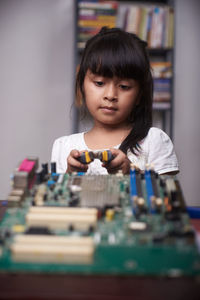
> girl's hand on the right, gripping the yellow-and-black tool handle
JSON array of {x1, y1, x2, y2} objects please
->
[{"x1": 102, "y1": 149, "x2": 131, "y2": 174}]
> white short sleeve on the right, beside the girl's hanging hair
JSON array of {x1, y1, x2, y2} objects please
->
[{"x1": 147, "y1": 128, "x2": 179, "y2": 174}]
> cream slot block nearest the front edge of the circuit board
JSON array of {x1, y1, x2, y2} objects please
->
[{"x1": 10, "y1": 235, "x2": 94, "y2": 264}]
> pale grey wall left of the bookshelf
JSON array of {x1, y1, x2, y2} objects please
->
[{"x1": 0, "y1": 0, "x2": 74, "y2": 199}]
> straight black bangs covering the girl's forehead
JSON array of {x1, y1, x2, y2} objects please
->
[{"x1": 85, "y1": 36, "x2": 146, "y2": 84}]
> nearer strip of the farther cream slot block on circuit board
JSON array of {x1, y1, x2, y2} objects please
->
[{"x1": 26, "y1": 213, "x2": 97, "y2": 231}]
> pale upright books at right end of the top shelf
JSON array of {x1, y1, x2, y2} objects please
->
[{"x1": 117, "y1": 2, "x2": 174, "y2": 48}]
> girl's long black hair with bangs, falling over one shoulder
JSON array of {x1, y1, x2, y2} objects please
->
[{"x1": 76, "y1": 27, "x2": 153, "y2": 154}]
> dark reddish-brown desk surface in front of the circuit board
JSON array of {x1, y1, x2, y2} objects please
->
[{"x1": 0, "y1": 274, "x2": 200, "y2": 300}]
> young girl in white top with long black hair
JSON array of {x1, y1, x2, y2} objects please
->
[{"x1": 51, "y1": 27, "x2": 178, "y2": 174}]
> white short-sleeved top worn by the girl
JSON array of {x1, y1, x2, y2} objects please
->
[{"x1": 51, "y1": 127, "x2": 179, "y2": 174}]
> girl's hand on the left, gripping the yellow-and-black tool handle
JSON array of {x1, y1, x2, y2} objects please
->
[{"x1": 66, "y1": 149, "x2": 88, "y2": 173}]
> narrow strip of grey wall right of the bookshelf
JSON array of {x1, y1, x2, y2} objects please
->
[{"x1": 174, "y1": 0, "x2": 200, "y2": 205}]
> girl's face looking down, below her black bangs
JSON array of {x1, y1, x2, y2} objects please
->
[{"x1": 84, "y1": 70, "x2": 139, "y2": 126}]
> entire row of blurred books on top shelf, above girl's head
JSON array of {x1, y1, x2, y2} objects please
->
[{"x1": 78, "y1": 0, "x2": 174, "y2": 49}]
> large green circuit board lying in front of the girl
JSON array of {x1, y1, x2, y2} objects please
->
[{"x1": 0, "y1": 159, "x2": 200, "y2": 277}]
